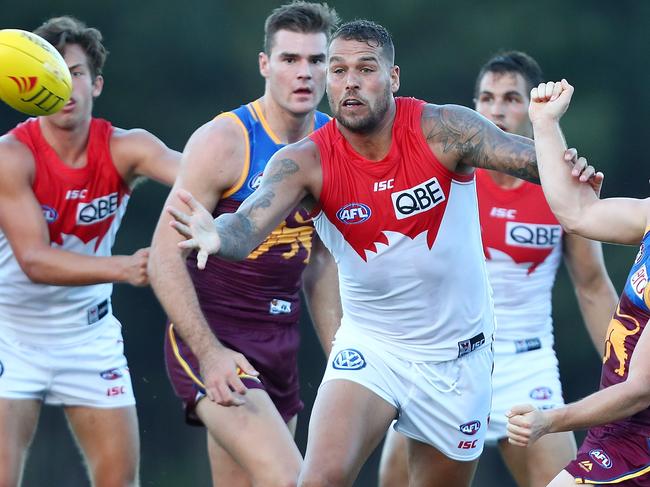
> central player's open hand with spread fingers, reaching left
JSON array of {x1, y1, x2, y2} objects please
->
[{"x1": 166, "y1": 189, "x2": 221, "y2": 269}]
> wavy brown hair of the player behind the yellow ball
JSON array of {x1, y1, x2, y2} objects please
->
[{"x1": 34, "y1": 15, "x2": 108, "y2": 80}]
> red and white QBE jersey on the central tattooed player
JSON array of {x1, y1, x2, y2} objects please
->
[{"x1": 310, "y1": 98, "x2": 494, "y2": 361}]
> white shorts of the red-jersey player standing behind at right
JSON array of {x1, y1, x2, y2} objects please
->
[{"x1": 486, "y1": 347, "x2": 564, "y2": 444}]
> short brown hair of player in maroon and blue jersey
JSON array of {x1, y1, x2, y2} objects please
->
[{"x1": 264, "y1": 1, "x2": 339, "y2": 54}]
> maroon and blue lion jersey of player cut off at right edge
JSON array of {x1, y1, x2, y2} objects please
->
[{"x1": 600, "y1": 227, "x2": 650, "y2": 436}]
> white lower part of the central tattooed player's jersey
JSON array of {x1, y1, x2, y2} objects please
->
[{"x1": 314, "y1": 181, "x2": 494, "y2": 361}]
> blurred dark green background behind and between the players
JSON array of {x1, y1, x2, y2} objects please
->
[{"x1": 0, "y1": 0, "x2": 650, "y2": 487}]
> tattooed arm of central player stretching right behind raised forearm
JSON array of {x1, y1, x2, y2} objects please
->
[{"x1": 422, "y1": 105, "x2": 539, "y2": 184}]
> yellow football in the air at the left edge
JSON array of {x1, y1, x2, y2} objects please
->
[{"x1": 0, "y1": 29, "x2": 72, "y2": 115}]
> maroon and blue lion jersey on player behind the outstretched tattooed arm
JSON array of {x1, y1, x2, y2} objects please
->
[{"x1": 187, "y1": 101, "x2": 329, "y2": 333}]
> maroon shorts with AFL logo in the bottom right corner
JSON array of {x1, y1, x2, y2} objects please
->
[{"x1": 565, "y1": 426, "x2": 650, "y2": 487}]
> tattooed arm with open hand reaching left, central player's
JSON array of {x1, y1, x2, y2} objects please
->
[{"x1": 167, "y1": 139, "x2": 322, "y2": 269}]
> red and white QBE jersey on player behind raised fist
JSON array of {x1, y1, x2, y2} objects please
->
[{"x1": 476, "y1": 169, "x2": 563, "y2": 348}]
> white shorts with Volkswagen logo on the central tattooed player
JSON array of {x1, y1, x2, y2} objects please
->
[{"x1": 323, "y1": 330, "x2": 492, "y2": 461}]
